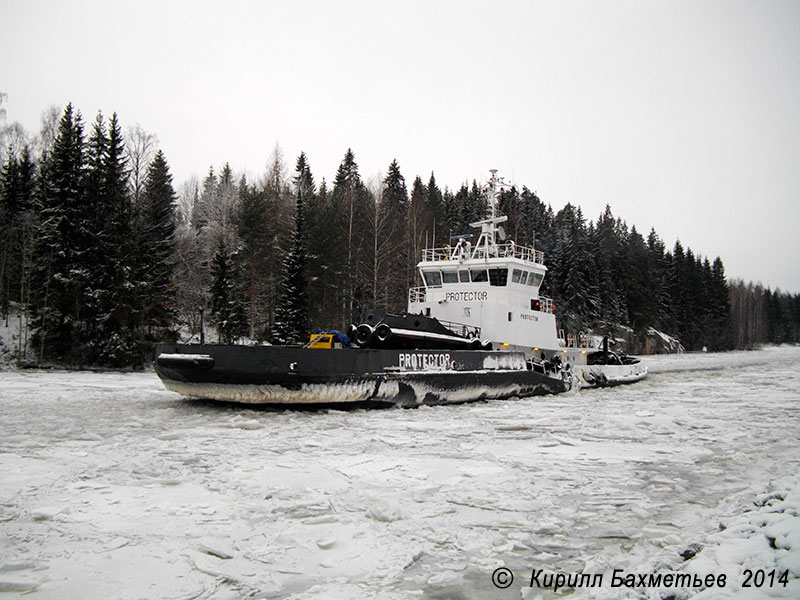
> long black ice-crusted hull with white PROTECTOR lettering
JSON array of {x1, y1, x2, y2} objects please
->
[{"x1": 155, "y1": 344, "x2": 568, "y2": 406}]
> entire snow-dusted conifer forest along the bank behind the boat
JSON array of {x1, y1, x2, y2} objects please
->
[{"x1": 0, "y1": 105, "x2": 800, "y2": 367}]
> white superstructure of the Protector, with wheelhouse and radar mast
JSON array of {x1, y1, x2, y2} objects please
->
[{"x1": 408, "y1": 170, "x2": 563, "y2": 357}]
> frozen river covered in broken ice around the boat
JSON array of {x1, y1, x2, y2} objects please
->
[{"x1": 0, "y1": 348, "x2": 800, "y2": 599}]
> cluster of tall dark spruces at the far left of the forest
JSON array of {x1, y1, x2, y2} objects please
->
[{"x1": 0, "y1": 105, "x2": 176, "y2": 366}]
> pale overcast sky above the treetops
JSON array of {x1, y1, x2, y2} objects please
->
[{"x1": 0, "y1": 0, "x2": 800, "y2": 293}]
